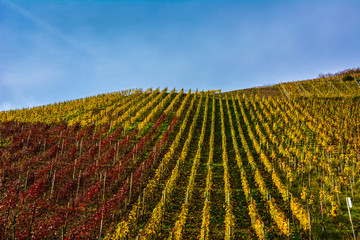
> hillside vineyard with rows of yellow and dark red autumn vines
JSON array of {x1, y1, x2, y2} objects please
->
[{"x1": 0, "y1": 75, "x2": 360, "y2": 240}]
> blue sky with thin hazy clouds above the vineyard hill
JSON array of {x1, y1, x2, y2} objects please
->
[{"x1": 0, "y1": 0, "x2": 360, "y2": 110}]
